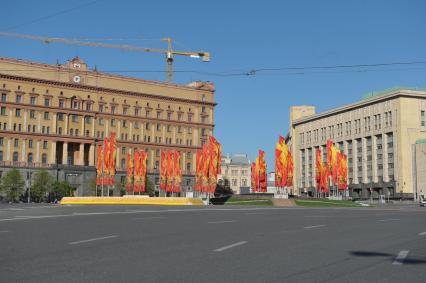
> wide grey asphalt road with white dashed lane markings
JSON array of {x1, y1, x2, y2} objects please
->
[{"x1": 0, "y1": 204, "x2": 426, "y2": 282}]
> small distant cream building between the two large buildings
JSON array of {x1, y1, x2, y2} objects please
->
[{"x1": 218, "y1": 154, "x2": 251, "y2": 194}]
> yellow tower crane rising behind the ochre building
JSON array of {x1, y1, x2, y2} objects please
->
[{"x1": 0, "y1": 32, "x2": 210, "y2": 82}]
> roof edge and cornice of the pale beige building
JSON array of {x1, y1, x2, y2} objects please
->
[{"x1": 292, "y1": 87, "x2": 426, "y2": 125}]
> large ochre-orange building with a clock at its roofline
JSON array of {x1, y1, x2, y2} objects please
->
[{"x1": 0, "y1": 57, "x2": 216, "y2": 195}]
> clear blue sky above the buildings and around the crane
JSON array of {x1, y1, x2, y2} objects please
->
[{"x1": 0, "y1": 0, "x2": 426, "y2": 170}]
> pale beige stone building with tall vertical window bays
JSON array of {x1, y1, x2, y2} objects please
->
[{"x1": 288, "y1": 88, "x2": 426, "y2": 201}]
